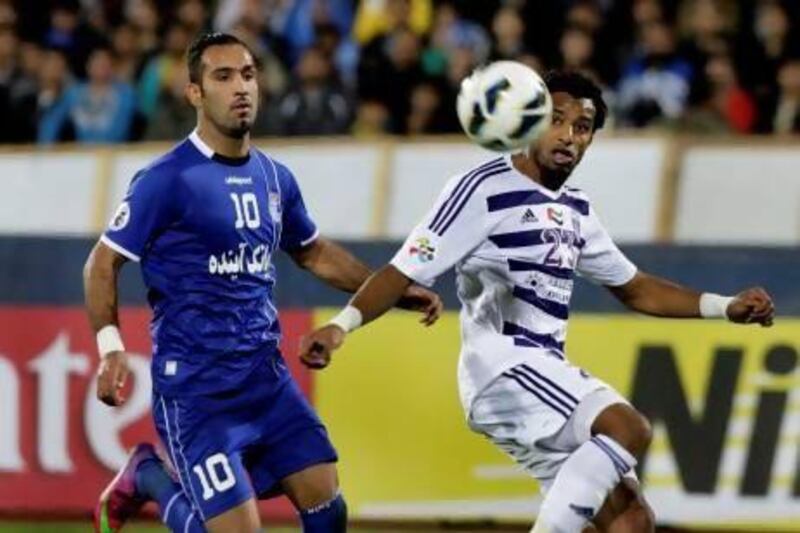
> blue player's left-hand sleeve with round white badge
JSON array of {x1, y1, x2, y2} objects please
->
[{"x1": 100, "y1": 165, "x2": 175, "y2": 262}]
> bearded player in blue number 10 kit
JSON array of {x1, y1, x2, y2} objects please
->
[{"x1": 84, "y1": 33, "x2": 441, "y2": 533}]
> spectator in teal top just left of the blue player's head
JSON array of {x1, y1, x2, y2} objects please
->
[{"x1": 138, "y1": 24, "x2": 191, "y2": 119}]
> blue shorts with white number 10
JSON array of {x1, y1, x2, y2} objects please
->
[{"x1": 153, "y1": 354, "x2": 337, "y2": 521}]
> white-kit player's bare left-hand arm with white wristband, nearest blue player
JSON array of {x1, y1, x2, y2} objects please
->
[{"x1": 300, "y1": 265, "x2": 416, "y2": 369}]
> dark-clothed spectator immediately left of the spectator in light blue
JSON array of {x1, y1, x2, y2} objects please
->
[{"x1": 9, "y1": 49, "x2": 70, "y2": 143}]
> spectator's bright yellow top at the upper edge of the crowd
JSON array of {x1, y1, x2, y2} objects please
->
[{"x1": 353, "y1": 0, "x2": 433, "y2": 45}]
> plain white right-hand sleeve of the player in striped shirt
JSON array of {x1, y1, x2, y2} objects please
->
[{"x1": 576, "y1": 208, "x2": 637, "y2": 287}]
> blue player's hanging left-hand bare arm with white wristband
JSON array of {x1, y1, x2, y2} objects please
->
[{"x1": 83, "y1": 242, "x2": 128, "y2": 405}]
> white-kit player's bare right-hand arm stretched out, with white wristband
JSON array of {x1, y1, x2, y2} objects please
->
[{"x1": 609, "y1": 272, "x2": 775, "y2": 327}]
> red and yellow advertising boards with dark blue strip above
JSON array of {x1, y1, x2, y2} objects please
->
[{"x1": 0, "y1": 237, "x2": 800, "y2": 530}]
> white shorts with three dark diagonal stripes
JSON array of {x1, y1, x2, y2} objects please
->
[{"x1": 468, "y1": 354, "x2": 628, "y2": 491}]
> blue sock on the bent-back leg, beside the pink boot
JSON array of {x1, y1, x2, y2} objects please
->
[{"x1": 136, "y1": 461, "x2": 206, "y2": 533}]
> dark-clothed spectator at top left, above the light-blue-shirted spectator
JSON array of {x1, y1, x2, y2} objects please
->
[{"x1": 44, "y1": 0, "x2": 105, "y2": 77}]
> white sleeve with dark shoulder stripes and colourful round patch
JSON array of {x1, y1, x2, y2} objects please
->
[{"x1": 391, "y1": 171, "x2": 489, "y2": 287}]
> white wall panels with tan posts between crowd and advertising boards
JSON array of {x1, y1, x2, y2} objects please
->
[{"x1": 0, "y1": 135, "x2": 800, "y2": 245}]
